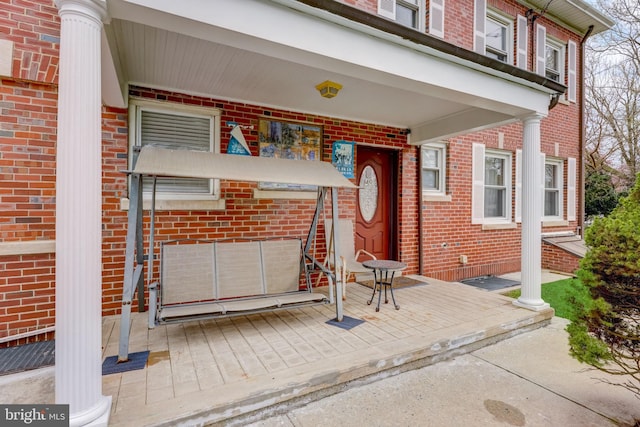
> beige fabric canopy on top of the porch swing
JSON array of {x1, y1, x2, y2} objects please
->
[{"x1": 133, "y1": 147, "x2": 356, "y2": 188}]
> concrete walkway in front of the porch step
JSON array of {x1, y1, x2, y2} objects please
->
[{"x1": 242, "y1": 317, "x2": 640, "y2": 427}]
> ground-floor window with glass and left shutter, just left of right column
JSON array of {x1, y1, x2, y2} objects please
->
[{"x1": 471, "y1": 144, "x2": 512, "y2": 225}]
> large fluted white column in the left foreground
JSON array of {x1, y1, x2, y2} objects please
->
[{"x1": 55, "y1": 0, "x2": 111, "y2": 426}]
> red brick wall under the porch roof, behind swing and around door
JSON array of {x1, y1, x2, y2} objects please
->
[{"x1": 102, "y1": 87, "x2": 410, "y2": 315}]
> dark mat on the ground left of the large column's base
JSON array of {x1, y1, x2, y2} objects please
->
[{"x1": 0, "y1": 340, "x2": 56, "y2": 375}]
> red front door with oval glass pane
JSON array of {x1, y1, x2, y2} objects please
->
[{"x1": 355, "y1": 146, "x2": 396, "y2": 259}]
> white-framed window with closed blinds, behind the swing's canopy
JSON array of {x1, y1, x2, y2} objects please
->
[{"x1": 129, "y1": 99, "x2": 220, "y2": 200}]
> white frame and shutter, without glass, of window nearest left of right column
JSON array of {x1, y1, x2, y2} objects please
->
[{"x1": 471, "y1": 143, "x2": 513, "y2": 226}]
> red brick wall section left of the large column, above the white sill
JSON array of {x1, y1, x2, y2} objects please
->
[{"x1": 0, "y1": 79, "x2": 58, "y2": 242}]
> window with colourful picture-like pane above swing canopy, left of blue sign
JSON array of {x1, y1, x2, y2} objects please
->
[{"x1": 258, "y1": 119, "x2": 322, "y2": 190}]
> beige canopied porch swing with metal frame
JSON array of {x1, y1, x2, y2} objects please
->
[{"x1": 118, "y1": 146, "x2": 356, "y2": 362}]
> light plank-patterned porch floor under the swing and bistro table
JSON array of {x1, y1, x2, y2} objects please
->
[{"x1": 102, "y1": 276, "x2": 553, "y2": 426}]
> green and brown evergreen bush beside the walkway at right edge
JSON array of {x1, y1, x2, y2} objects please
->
[{"x1": 567, "y1": 173, "x2": 640, "y2": 396}]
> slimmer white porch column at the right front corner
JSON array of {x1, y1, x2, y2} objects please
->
[{"x1": 514, "y1": 114, "x2": 549, "y2": 311}]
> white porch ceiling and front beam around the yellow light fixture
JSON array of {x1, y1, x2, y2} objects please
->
[{"x1": 103, "y1": 0, "x2": 554, "y2": 143}]
